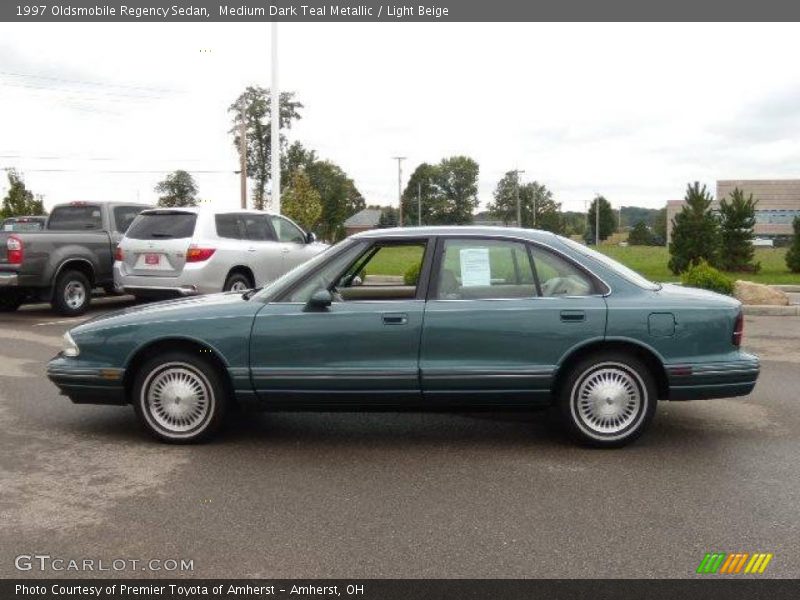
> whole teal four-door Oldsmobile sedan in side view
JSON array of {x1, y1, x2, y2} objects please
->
[{"x1": 48, "y1": 227, "x2": 759, "y2": 447}]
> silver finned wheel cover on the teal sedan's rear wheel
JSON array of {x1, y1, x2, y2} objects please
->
[{"x1": 570, "y1": 363, "x2": 649, "y2": 439}]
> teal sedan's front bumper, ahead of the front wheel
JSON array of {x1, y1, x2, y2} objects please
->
[{"x1": 47, "y1": 355, "x2": 127, "y2": 405}]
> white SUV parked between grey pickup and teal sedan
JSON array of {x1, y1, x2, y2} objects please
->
[{"x1": 114, "y1": 208, "x2": 327, "y2": 298}]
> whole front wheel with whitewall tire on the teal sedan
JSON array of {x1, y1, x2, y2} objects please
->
[{"x1": 131, "y1": 351, "x2": 229, "y2": 444}]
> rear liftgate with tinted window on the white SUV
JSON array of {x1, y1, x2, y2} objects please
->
[{"x1": 121, "y1": 209, "x2": 197, "y2": 277}]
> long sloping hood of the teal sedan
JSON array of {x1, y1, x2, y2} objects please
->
[{"x1": 71, "y1": 292, "x2": 264, "y2": 334}]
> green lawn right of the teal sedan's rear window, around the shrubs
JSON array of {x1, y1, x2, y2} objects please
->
[{"x1": 600, "y1": 244, "x2": 800, "y2": 284}]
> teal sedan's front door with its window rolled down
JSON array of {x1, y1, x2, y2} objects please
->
[{"x1": 250, "y1": 240, "x2": 428, "y2": 407}]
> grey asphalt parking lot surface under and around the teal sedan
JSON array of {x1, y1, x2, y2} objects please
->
[{"x1": 0, "y1": 298, "x2": 800, "y2": 578}]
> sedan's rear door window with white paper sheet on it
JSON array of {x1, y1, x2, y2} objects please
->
[{"x1": 434, "y1": 239, "x2": 536, "y2": 300}]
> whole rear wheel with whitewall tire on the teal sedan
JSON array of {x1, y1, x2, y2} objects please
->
[{"x1": 558, "y1": 352, "x2": 658, "y2": 448}]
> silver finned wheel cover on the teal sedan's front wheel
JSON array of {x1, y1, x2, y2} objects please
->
[{"x1": 142, "y1": 363, "x2": 214, "y2": 436}]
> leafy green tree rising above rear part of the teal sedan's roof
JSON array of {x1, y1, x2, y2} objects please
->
[{"x1": 488, "y1": 171, "x2": 566, "y2": 233}]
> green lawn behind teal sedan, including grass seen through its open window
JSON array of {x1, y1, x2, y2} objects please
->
[{"x1": 367, "y1": 239, "x2": 800, "y2": 285}]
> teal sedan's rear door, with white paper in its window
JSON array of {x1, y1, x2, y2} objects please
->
[{"x1": 420, "y1": 237, "x2": 606, "y2": 406}]
